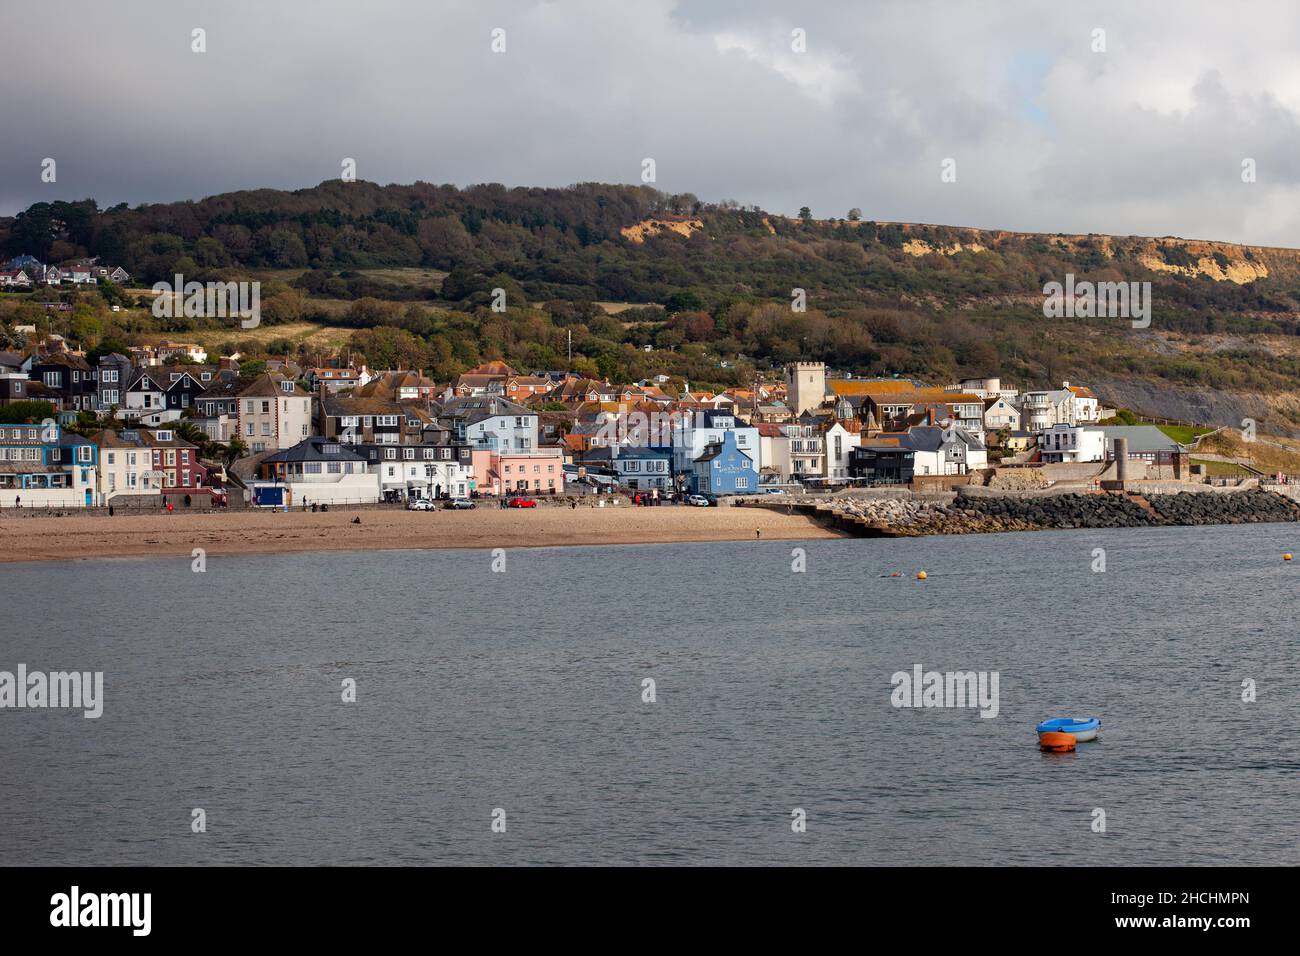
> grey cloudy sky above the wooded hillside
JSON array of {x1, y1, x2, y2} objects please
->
[{"x1": 0, "y1": 0, "x2": 1300, "y2": 246}]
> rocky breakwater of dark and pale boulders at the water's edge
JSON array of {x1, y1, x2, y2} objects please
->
[{"x1": 835, "y1": 492, "x2": 1300, "y2": 537}]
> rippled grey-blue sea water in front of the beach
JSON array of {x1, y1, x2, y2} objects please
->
[{"x1": 0, "y1": 525, "x2": 1300, "y2": 865}]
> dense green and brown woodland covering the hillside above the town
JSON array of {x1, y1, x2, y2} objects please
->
[{"x1": 0, "y1": 181, "x2": 1300, "y2": 390}]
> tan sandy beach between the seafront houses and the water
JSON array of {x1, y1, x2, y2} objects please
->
[{"x1": 0, "y1": 505, "x2": 837, "y2": 563}]
